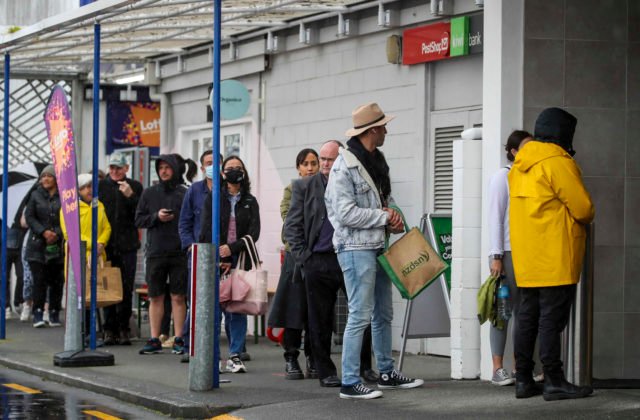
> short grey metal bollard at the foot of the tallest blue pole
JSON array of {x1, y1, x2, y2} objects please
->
[{"x1": 189, "y1": 244, "x2": 218, "y2": 391}]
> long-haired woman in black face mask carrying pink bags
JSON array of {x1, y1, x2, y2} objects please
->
[{"x1": 199, "y1": 156, "x2": 260, "y2": 373}]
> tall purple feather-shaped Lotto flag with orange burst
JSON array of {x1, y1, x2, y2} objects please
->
[{"x1": 44, "y1": 85, "x2": 82, "y2": 305}]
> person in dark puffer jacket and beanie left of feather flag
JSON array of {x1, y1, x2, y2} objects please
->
[{"x1": 25, "y1": 165, "x2": 64, "y2": 328}]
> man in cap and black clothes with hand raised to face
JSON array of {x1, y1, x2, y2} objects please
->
[{"x1": 98, "y1": 153, "x2": 142, "y2": 346}]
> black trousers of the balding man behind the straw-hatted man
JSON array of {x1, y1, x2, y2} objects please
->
[{"x1": 302, "y1": 252, "x2": 371, "y2": 379}]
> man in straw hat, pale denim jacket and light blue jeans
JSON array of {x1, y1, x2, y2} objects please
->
[{"x1": 325, "y1": 103, "x2": 423, "y2": 399}]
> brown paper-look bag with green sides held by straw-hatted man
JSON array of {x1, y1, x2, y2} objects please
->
[{"x1": 378, "y1": 209, "x2": 448, "y2": 300}]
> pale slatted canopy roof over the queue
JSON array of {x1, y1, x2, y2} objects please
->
[{"x1": 0, "y1": 0, "x2": 363, "y2": 75}]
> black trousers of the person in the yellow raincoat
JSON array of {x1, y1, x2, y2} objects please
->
[{"x1": 514, "y1": 284, "x2": 576, "y2": 382}]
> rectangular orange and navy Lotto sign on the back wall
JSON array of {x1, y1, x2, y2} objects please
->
[{"x1": 107, "y1": 101, "x2": 160, "y2": 154}]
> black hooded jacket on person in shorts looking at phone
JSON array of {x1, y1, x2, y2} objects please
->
[{"x1": 135, "y1": 155, "x2": 187, "y2": 257}]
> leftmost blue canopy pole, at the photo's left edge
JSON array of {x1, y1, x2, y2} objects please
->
[{"x1": 0, "y1": 54, "x2": 10, "y2": 340}]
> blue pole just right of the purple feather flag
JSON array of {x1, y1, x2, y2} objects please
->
[{"x1": 89, "y1": 23, "x2": 100, "y2": 350}]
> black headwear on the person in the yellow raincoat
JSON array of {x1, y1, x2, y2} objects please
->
[{"x1": 533, "y1": 108, "x2": 578, "y2": 156}]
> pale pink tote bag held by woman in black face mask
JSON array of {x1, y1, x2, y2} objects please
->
[{"x1": 223, "y1": 235, "x2": 269, "y2": 315}]
